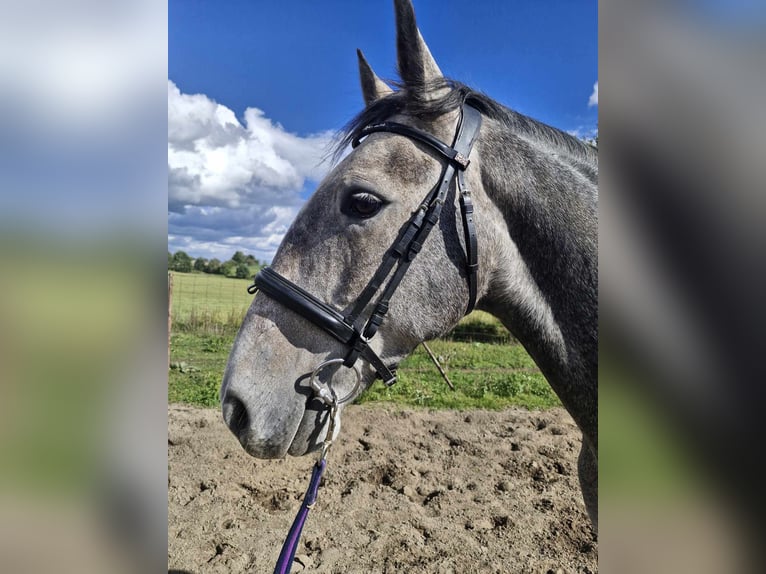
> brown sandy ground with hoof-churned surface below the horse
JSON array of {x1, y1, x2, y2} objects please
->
[{"x1": 168, "y1": 405, "x2": 598, "y2": 574}]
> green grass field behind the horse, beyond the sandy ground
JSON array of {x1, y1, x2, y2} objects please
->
[{"x1": 168, "y1": 273, "x2": 560, "y2": 409}]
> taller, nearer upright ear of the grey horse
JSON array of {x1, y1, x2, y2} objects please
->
[{"x1": 394, "y1": 0, "x2": 444, "y2": 96}]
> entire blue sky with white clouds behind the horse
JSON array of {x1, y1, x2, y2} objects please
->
[{"x1": 168, "y1": 0, "x2": 598, "y2": 260}]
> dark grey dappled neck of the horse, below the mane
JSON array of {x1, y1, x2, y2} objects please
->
[{"x1": 481, "y1": 122, "x2": 598, "y2": 431}]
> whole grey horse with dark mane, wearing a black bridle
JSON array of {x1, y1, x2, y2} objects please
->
[{"x1": 221, "y1": 0, "x2": 598, "y2": 526}]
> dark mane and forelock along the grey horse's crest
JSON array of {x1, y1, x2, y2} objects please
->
[{"x1": 334, "y1": 79, "x2": 598, "y2": 164}]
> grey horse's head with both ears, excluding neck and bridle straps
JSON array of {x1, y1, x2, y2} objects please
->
[{"x1": 221, "y1": 0, "x2": 492, "y2": 458}]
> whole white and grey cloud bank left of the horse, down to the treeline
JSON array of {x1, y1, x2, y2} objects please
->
[{"x1": 168, "y1": 81, "x2": 332, "y2": 259}]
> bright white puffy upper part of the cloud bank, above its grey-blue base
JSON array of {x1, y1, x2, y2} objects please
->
[{"x1": 168, "y1": 81, "x2": 331, "y2": 211}]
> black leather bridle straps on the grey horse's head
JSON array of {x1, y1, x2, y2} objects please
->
[{"x1": 248, "y1": 104, "x2": 481, "y2": 392}]
